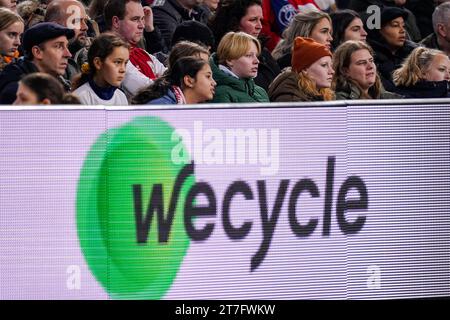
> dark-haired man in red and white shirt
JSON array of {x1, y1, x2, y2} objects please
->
[{"x1": 105, "y1": 0, "x2": 166, "y2": 97}]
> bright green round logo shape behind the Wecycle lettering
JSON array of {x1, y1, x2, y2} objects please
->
[{"x1": 77, "y1": 117, "x2": 194, "y2": 299}]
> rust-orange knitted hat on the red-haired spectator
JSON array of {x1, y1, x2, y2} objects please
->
[{"x1": 291, "y1": 37, "x2": 332, "y2": 72}]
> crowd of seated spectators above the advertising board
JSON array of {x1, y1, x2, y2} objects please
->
[{"x1": 0, "y1": 0, "x2": 450, "y2": 105}]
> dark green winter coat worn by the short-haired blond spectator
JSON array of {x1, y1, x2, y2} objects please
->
[{"x1": 209, "y1": 53, "x2": 269, "y2": 103}]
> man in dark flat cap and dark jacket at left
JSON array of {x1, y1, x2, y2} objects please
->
[{"x1": 0, "y1": 22, "x2": 75, "y2": 104}]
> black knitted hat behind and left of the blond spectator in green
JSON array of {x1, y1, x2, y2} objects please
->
[{"x1": 172, "y1": 20, "x2": 214, "y2": 48}]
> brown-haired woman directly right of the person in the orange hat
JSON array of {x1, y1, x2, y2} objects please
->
[{"x1": 333, "y1": 40, "x2": 400, "y2": 100}]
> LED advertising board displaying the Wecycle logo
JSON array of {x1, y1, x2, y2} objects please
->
[{"x1": 0, "y1": 103, "x2": 450, "y2": 299}]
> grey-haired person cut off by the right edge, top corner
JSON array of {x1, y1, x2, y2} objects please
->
[{"x1": 420, "y1": 2, "x2": 450, "y2": 56}]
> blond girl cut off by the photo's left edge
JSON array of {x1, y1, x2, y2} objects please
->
[{"x1": 0, "y1": 8, "x2": 24, "y2": 72}]
